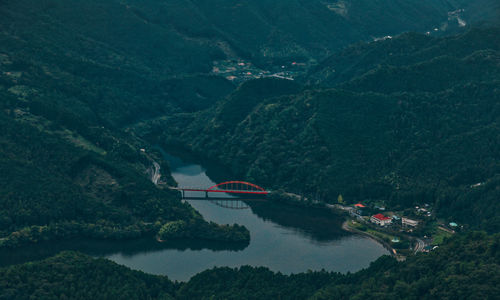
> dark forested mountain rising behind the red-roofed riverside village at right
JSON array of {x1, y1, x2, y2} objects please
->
[{"x1": 137, "y1": 28, "x2": 500, "y2": 231}]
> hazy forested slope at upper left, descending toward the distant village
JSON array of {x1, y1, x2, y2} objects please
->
[{"x1": 0, "y1": 0, "x2": 233, "y2": 126}]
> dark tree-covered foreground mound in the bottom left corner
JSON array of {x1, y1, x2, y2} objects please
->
[{"x1": 0, "y1": 252, "x2": 175, "y2": 299}]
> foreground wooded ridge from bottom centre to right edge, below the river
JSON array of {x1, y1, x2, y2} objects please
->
[{"x1": 178, "y1": 232, "x2": 500, "y2": 299}]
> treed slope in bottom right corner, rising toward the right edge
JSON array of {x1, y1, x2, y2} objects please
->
[{"x1": 312, "y1": 232, "x2": 500, "y2": 299}]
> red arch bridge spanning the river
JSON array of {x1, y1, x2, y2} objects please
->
[{"x1": 172, "y1": 181, "x2": 270, "y2": 198}]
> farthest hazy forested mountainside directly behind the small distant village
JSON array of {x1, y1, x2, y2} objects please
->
[{"x1": 122, "y1": 0, "x2": 495, "y2": 65}]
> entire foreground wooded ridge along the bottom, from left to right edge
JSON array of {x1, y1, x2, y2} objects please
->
[{"x1": 0, "y1": 232, "x2": 500, "y2": 299}]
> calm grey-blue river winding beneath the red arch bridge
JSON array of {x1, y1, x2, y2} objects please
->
[{"x1": 0, "y1": 153, "x2": 389, "y2": 281}]
